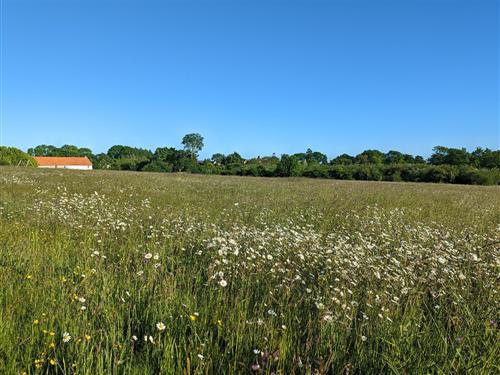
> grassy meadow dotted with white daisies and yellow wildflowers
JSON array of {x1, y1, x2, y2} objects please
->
[{"x1": 0, "y1": 168, "x2": 500, "y2": 374}]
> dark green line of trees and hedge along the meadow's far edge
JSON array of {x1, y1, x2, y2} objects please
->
[{"x1": 0, "y1": 133, "x2": 500, "y2": 185}]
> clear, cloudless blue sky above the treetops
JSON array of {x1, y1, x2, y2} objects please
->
[{"x1": 1, "y1": 0, "x2": 500, "y2": 157}]
